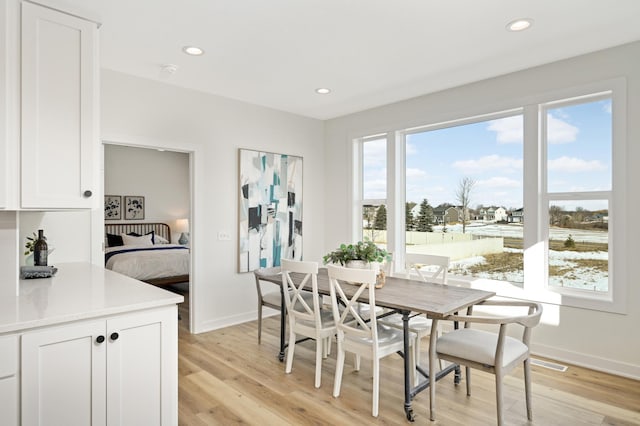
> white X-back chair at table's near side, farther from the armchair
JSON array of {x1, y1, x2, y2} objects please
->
[{"x1": 281, "y1": 259, "x2": 336, "y2": 388}]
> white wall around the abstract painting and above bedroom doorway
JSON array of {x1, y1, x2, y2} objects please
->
[{"x1": 101, "y1": 70, "x2": 325, "y2": 332}]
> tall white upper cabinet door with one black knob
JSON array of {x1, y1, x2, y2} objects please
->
[{"x1": 21, "y1": 2, "x2": 99, "y2": 209}]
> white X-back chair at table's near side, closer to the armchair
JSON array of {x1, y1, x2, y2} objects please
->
[{"x1": 327, "y1": 265, "x2": 415, "y2": 417}]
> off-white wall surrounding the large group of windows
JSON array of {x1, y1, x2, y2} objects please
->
[{"x1": 324, "y1": 42, "x2": 640, "y2": 377}]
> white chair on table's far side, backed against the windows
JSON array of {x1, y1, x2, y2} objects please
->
[{"x1": 380, "y1": 253, "x2": 449, "y2": 383}]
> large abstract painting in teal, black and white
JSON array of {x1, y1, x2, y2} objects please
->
[{"x1": 238, "y1": 149, "x2": 302, "y2": 272}]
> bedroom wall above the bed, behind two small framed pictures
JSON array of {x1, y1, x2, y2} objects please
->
[{"x1": 104, "y1": 144, "x2": 190, "y2": 241}]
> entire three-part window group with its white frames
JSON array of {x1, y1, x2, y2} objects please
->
[{"x1": 354, "y1": 80, "x2": 626, "y2": 312}]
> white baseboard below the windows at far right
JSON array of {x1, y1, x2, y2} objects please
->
[{"x1": 531, "y1": 343, "x2": 640, "y2": 380}]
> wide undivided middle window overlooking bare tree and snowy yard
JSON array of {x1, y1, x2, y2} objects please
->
[{"x1": 405, "y1": 114, "x2": 524, "y2": 284}]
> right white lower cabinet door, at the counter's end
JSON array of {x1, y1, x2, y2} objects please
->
[{"x1": 107, "y1": 306, "x2": 178, "y2": 426}]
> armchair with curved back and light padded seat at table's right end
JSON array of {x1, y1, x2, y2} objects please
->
[{"x1": 429, "y1": 300, "x2": 542, "y2": 426}]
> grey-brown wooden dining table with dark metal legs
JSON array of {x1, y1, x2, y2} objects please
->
[{"x1": 260, "y1": 268, "x2": 495, "y2": 421}]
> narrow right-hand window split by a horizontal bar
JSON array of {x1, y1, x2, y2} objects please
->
[{"x1": 541, "y1": 93, "x2": 613, "y2": 293}]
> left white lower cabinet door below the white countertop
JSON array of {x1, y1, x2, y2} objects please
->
[{"x1": 21, "y1": 320, "x2": 107, "y2": 426}]
